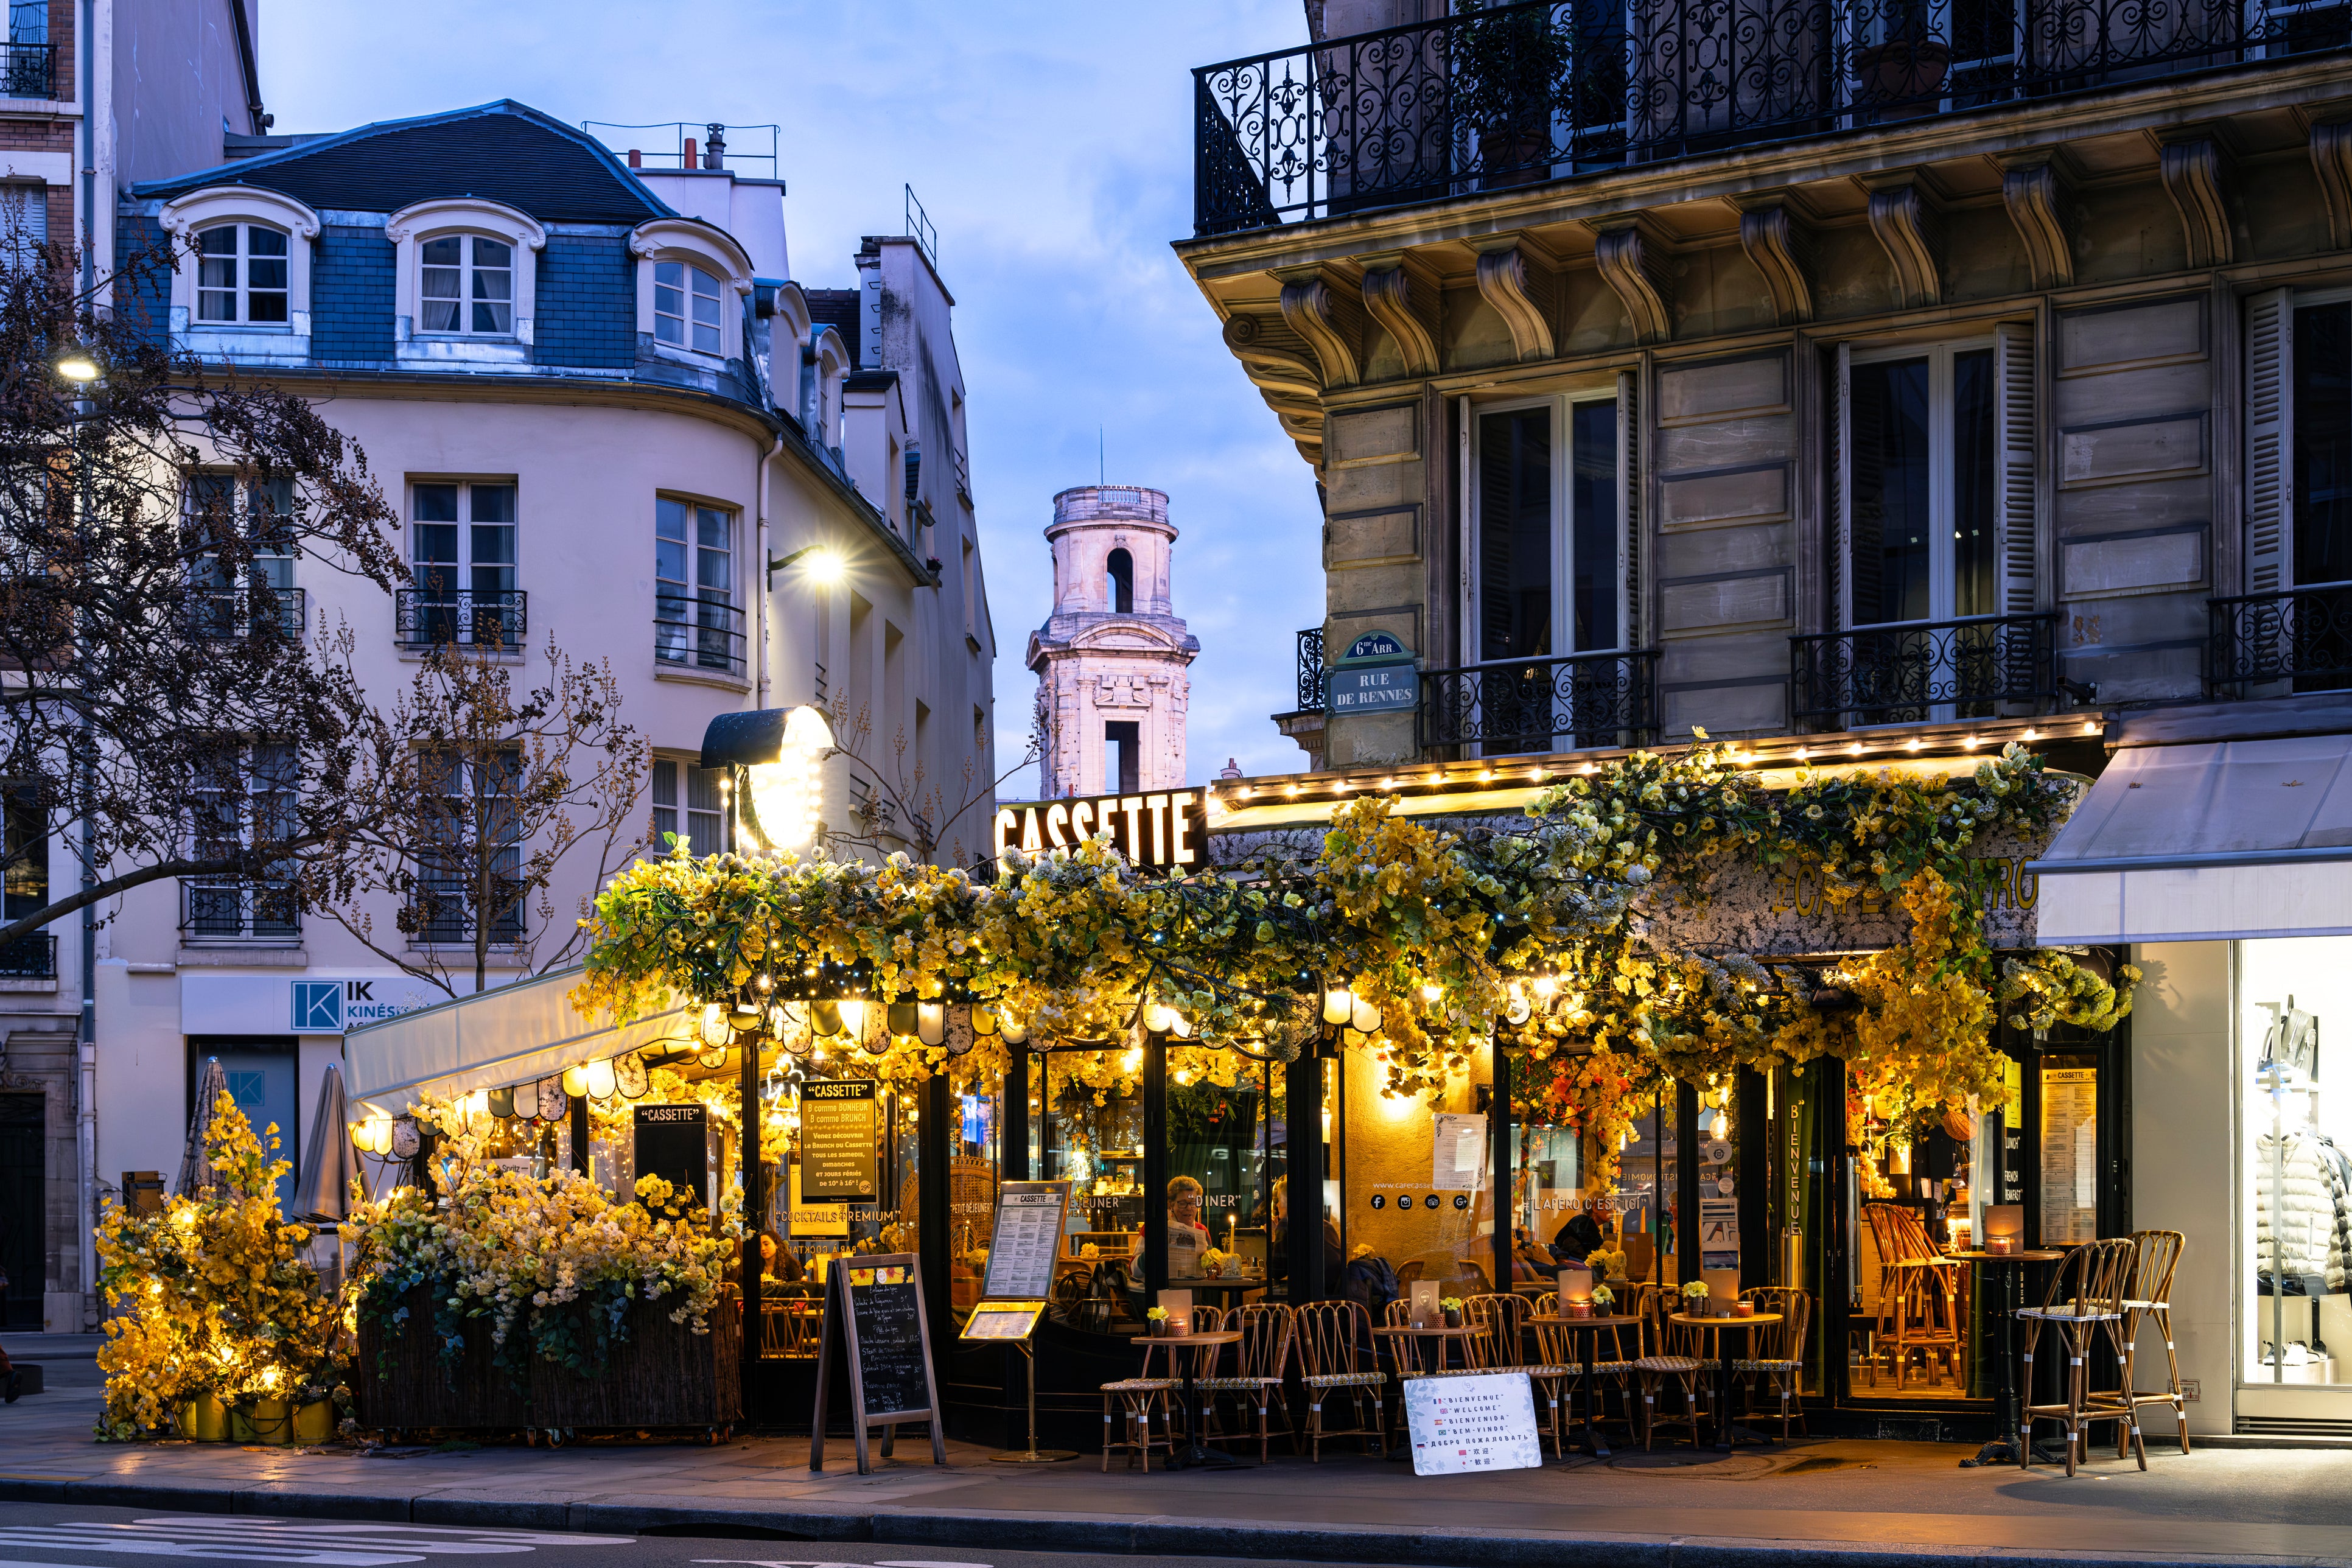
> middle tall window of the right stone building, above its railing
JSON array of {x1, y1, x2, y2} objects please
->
[{"x1": 1846, "y1": 346, "x2": 1999, "y2": 625}]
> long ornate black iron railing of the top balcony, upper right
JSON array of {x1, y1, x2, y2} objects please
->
[{"x1": 1192, "y1": 0, "x2": 2352, "y2": 235}]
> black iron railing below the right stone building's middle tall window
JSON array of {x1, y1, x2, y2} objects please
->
[{"x1": 1788, "y1": 614, "x2": 2058, "y2": 729}]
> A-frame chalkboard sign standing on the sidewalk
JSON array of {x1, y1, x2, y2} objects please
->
[{"x1": 809, "y1": 1253, "x2": 948, "y2": 1476}]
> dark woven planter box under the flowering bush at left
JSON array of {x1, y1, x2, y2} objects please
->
[{"x1": 351, "y1": 1290, "x2": 743, "y2": 1429}]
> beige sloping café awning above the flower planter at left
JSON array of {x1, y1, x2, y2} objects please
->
[{"x1": 343, "y1": 964, "x2": 696, "y2": 1116}]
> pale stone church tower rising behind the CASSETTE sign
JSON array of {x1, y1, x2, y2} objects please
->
[{"x1": 1028, "y1": 485, "x2": 1200, "y2": 799}]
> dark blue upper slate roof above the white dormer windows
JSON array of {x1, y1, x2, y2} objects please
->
[{"x1": 131, "y1": 99, "x2": 677, "y2": 226}]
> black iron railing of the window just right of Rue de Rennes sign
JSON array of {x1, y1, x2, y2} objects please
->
[{"x1": 1418, "y1": 649, "x2": 1658, "y2": 757}]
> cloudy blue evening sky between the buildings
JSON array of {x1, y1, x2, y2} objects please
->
[{"x1": 261, "y1": 0, "x2": 1322, "y2": 794}]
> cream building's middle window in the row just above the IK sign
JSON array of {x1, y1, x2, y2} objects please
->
[{"x1": 414, "y1": 750, "x2": 525, "y2": 943}]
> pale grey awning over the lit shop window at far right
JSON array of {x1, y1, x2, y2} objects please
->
[{"x1": 2032, "y1": 733, "x2": 2352, "y2": 947}]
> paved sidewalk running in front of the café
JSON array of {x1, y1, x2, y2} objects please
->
[{"x1": 0, "y1": 1368, "x2": 2352, "y2": 1568}]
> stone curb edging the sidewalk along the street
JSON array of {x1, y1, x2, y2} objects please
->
[{"x1": 0, "y1": 1476, "x2": 2352, "y2": 1568}]
